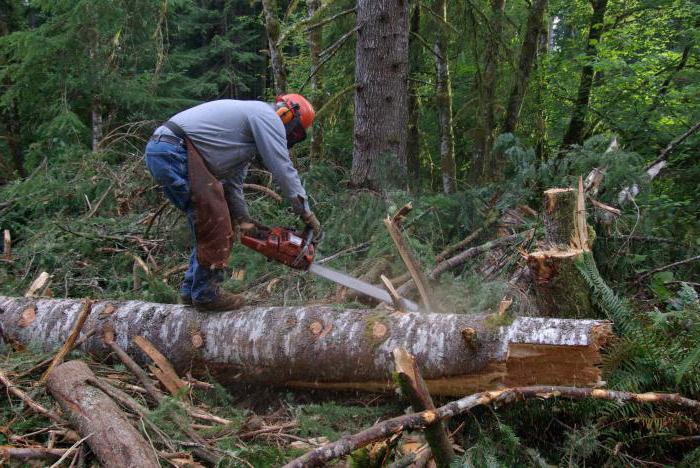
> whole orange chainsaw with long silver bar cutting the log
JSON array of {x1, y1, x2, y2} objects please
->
[{"x1": 241, "y1": 225, "x2": 420, "y2": 312}]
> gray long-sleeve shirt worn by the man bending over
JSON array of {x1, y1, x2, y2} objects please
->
[{"x1": 154, "y1": 99, "x2": 309, "y2": 218}]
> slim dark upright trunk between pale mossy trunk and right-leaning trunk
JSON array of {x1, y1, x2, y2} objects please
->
[{"x1": 475, "y1": 0, "x2": 506, "y2": 180}]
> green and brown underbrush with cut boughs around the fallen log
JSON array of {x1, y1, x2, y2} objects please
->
[{"x1": 0, "y1": 137, "x2": 700, "y2": 466}]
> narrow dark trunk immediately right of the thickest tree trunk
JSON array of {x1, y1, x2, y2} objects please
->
[{"x1": 406, "y1": 2, "x2": 422, "y2": 191}]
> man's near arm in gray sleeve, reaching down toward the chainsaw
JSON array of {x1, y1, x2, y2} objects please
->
[{"x1": 249, "y1": 112, "x2": 311, "y2": 215}]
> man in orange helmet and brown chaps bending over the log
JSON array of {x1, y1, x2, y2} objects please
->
[{"x1": 146, "y1": 94, "x2": 321, "y2": 311}]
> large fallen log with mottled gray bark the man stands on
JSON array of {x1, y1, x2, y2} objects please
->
[{"x1": 0, "y1": 296, "x2": 612, "y2": 395}]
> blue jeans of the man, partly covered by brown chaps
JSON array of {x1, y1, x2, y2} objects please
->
[{"x1": 146, "y1": 140, "x2": 224, "y2": 303}]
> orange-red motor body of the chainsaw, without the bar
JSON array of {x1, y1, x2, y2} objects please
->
[{"x1": 241, "y1": 227, "x2": 315, "y2": 270}]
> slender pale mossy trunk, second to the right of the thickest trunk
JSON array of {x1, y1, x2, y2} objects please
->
[{"x1": 434, "y1": 0, "x2": 457, "y2": 195}]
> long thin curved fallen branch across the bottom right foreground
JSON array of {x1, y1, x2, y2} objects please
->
[{"x1": 284, "y1": 386, "x2": 700, "y2": 468}]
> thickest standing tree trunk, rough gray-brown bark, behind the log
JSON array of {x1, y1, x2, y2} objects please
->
[{"x1": 352, "y1": 0, "x2": 408, "y2": 190}]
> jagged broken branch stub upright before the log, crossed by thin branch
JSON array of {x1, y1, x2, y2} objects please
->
[{"x1": 392, "y1": 348, "x2": 455, "y2": 468}]
